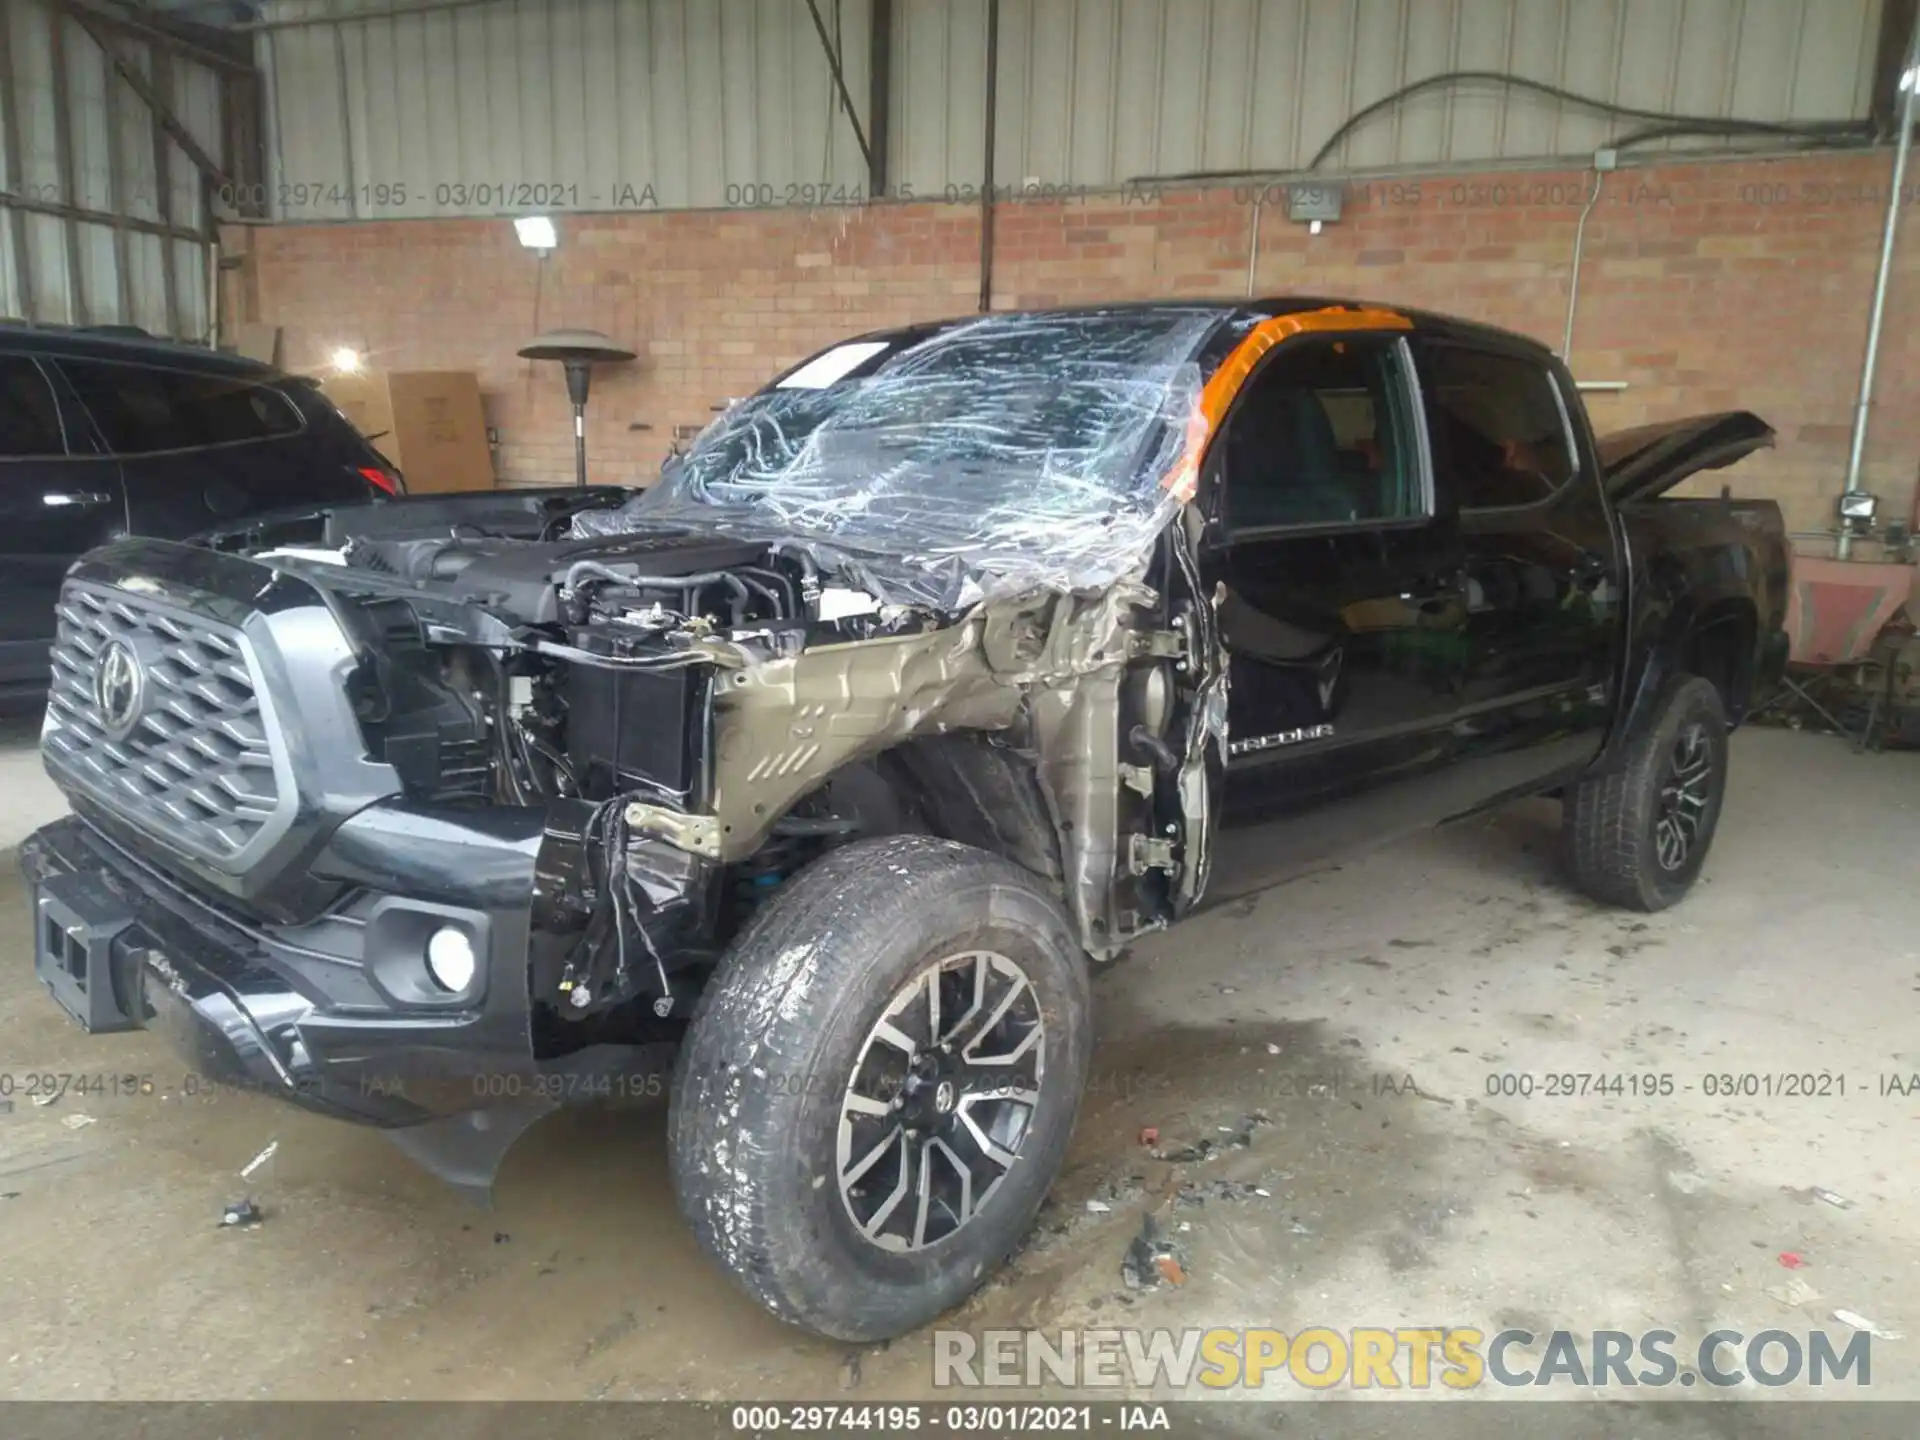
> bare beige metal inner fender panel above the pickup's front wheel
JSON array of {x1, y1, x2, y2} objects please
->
[{"x1": 624, "y1": 556, "x2": 1223, "y2": 960}]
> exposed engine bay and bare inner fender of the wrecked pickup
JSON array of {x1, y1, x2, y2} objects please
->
[{"x1": 213, "y1": 492, "x2": 1225, "y2": 1054}]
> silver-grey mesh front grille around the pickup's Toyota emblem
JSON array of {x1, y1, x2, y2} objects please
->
[{"x1": 40, "y1": 584, "x2": 284, "y2": 864}]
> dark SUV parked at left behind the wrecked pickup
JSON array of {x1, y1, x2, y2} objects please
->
[{"x1": 0, "y1": 326, "x2": 401, "y2": 697}]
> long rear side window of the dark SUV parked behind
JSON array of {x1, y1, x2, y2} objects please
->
[{"x1": 60, "y1": 361, "x2": 300, "y2": 455}]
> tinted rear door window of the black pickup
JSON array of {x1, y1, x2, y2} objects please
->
[{"x1": 1421, "y1": 346, "x2": 1572, "y2": 509}]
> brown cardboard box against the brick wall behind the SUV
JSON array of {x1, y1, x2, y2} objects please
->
[{"x1": 323, "y1": 371, "x2": 493, "y2": 495}]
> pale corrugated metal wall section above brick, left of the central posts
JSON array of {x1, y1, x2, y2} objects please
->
[{"x1": 259, "y1": 0, "x2": 868, "y2": 219}]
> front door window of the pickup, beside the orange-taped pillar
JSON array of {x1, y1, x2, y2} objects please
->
[{"x1": 1221, "y1": 340, "x2": 1425, "y2": 530}]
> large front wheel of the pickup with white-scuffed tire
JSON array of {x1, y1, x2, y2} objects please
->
[{"x1": 668, "y1": 835, "x2": 1092, "y2": 1340}]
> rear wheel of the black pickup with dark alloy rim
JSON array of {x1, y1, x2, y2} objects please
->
[{"x1": 1565, "y1": 676, "x2": 1726, "y2": 910}]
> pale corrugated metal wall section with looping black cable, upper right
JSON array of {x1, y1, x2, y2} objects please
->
[{"x1": 917, "y1": 0, "x2": 1880, "y2": 186}]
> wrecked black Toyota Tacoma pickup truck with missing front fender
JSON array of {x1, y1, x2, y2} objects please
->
[{"x1": 25, "y1": 300, "x2": 1788, "y2": 1338}]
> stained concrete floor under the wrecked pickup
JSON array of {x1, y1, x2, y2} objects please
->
[{"x1": 0, "y1": 732, "x2": 1920, "y2": 1400}]
